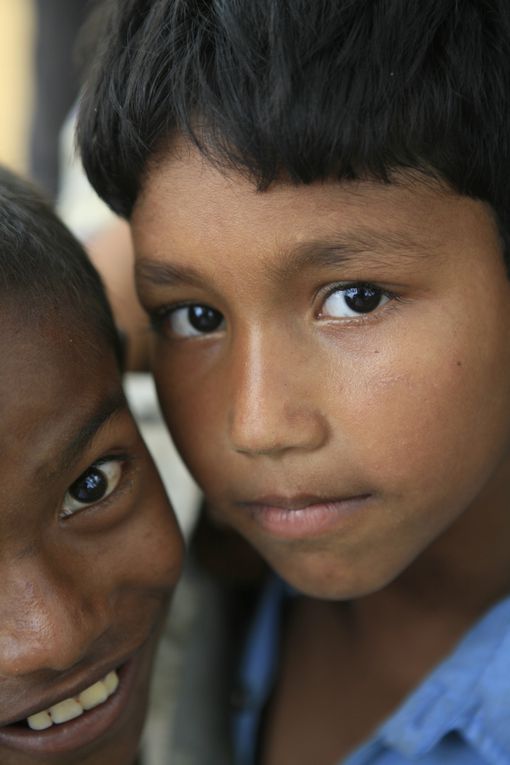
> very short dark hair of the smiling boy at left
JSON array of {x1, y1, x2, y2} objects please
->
[{"x1": 0, "y1": 166, "x2": 123, "y2": 367}]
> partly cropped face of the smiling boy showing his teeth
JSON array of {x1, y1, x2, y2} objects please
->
[{"x1": 0, "y1": 306, "x2": 182, "y2": 765}]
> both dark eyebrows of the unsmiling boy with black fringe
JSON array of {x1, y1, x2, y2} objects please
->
[{"x1": 135, "y1": 228, "x2": 434, "y2": 287}]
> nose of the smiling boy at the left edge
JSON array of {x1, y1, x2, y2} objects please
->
[{"x1": 0, "y1": 561, "x2": 103, "y2": 677}]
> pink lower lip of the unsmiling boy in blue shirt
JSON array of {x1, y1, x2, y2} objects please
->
[{"x1": 245, "y1": 494, "x2": 371, "y2": 539}]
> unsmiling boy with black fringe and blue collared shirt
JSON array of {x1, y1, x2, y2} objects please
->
[{"x1": 79, "y1": 0, "x2": 510, "y2": 765}]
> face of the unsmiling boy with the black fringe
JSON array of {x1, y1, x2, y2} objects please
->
[{"x1": 132, "y1": 146, "x2": 510, "y2": 598}]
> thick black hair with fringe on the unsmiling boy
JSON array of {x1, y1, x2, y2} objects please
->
[{"x1": 78, "y1": 0, "x2": 510, "y2": 254}]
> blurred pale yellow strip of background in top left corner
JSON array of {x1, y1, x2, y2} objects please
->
[{"x1": 0, "y1": 0, "x2": 33, "y2": 172}]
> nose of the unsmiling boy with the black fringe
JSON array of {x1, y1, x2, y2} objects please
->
[{"x1": 227, "y1": 326, "x2": 329, "y2": 456}]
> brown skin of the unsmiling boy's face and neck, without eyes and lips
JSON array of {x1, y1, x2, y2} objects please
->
[{"x1": 132, "y1": 142, "x2": 510, "y2": 764}]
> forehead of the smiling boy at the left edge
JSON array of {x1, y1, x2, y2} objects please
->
[{"x1": 0, "y1": 311, "x2": 127, "y2": 480}]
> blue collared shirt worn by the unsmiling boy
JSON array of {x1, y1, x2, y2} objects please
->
[{"x1": 233, "y1": 579, "x2": 510, "y2": 765}]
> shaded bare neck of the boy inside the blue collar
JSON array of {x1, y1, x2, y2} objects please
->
[{"x1": 262, "y1": 510, "x2": 510, "y2": 765}]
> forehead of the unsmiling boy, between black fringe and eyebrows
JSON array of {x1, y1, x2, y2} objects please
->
[{"x1": 131, "y1": 145, "x2": 495, "y2": 272}]
